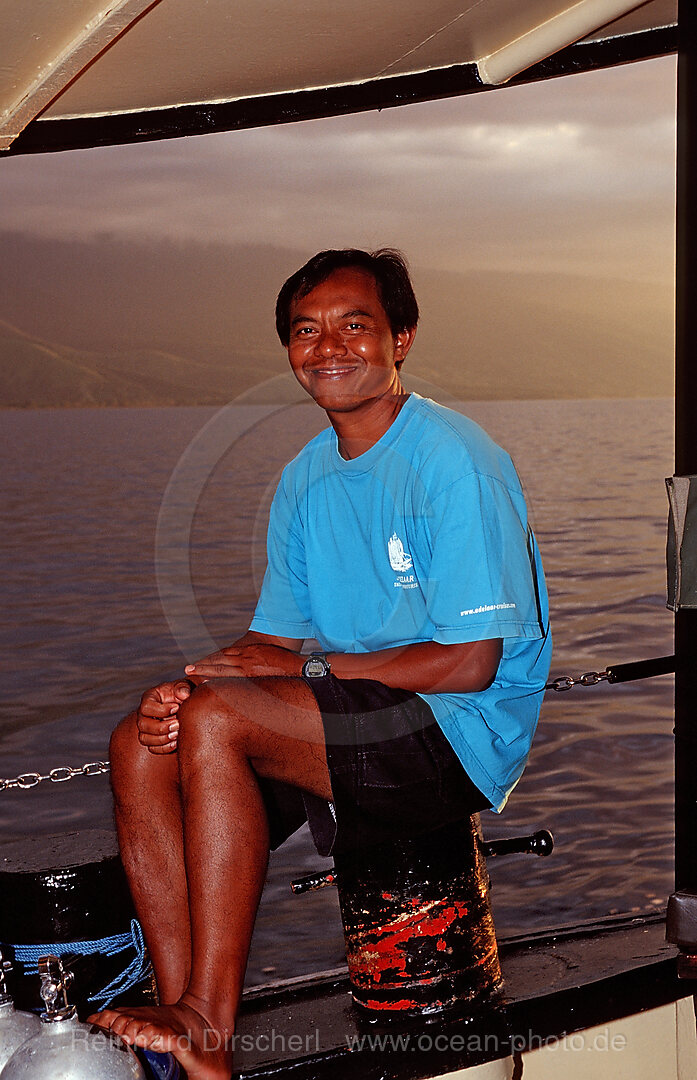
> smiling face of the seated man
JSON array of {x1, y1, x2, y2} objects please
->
[{"x1": 289, "y1": 267, "x2": 415, "y2": 413}]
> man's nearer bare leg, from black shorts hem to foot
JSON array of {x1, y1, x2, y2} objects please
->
[{"x1": 89, "y1": 678, "x2": 331, "y2": 1080}]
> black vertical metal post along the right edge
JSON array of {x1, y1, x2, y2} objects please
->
[{"x1": 675, "y1": 0, "x2": 697, "y2": 894}]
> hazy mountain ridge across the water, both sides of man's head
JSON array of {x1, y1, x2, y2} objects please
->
[{"x1": 0, "y1": 233, "x2": 672, "y2": 407}]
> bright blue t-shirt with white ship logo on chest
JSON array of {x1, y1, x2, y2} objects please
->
[{"x1": 251, "y1": 394, "x2": 551, "y2": 810}]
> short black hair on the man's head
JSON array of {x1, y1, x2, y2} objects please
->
[{"x1": 276, "y1": 247, "x2": 418, "y2": 347}]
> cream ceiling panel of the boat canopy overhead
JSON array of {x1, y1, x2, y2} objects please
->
[{"x1": 0, "y1": 0, "x2": 676, "y2": 147}]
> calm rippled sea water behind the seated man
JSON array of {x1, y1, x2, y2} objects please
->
[{"x1": 0, "y1": 400, "x2": 673, "y2": 983}]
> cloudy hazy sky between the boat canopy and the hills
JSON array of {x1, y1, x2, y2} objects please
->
[{"x1": 0, "y1": 57, "x2": 674, "y2": 279}]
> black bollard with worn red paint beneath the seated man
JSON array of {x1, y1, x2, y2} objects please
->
[{"x1": 336, "y1": 818, "x2": 502, "y2": 1018}]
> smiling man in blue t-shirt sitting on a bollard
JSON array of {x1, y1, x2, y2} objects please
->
[{"x1": 94, "y1": 251, "x2": 551, "y2": 1080}]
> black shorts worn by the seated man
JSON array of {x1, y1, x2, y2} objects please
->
[{"x1": 255, "y1": 675, "x2": 491, "y2": 855}]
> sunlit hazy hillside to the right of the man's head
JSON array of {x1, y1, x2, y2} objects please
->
[{"x1": 407, "y1": 271, "x2": 673, "y2": 401}]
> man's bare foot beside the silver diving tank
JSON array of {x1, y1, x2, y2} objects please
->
[{"x1": 88, "y1": 1000, "x2": 232, "y2": 1080}]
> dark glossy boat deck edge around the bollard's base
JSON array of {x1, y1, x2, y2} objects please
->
[{"x1": 234, "y1": 915, "x2": 682, "y2": 1080}]
